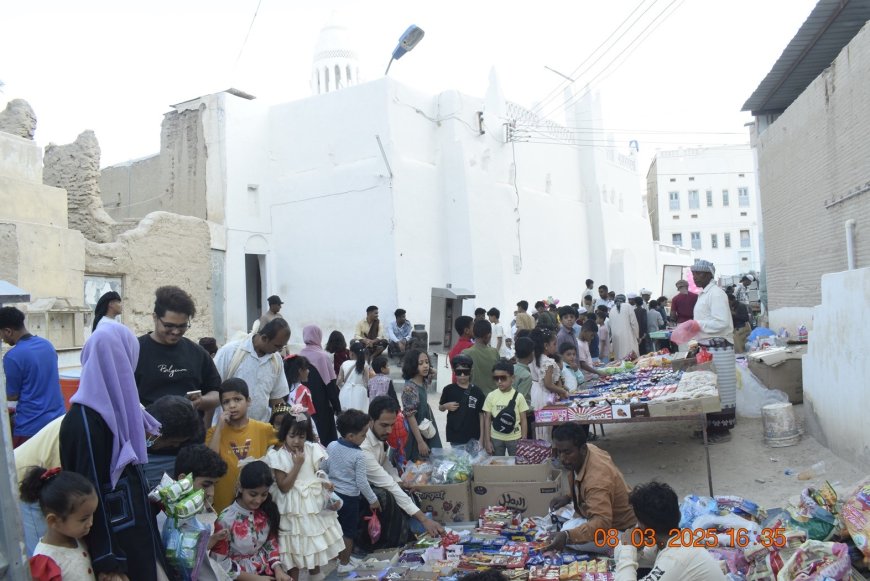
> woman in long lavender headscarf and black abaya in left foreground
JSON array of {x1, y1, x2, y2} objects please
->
[{"x1": 60, "y1": 320, "x2": 168, "y2": 581}]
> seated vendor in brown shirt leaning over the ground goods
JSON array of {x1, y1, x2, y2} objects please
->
[{"x1": 546, "y1": 424, "x2": 637, "y2": 551}]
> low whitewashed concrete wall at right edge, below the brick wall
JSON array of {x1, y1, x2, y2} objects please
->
[{"x1": 803, "y1": 268, "x2": 870, "y2": 464}]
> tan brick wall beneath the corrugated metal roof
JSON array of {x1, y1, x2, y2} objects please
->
[{"x1": 757, "y1": 20, "x2": 870, "y2": 310}]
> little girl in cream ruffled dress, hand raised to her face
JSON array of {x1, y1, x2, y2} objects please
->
[{"x1": 265, "y1": 412, "x2": 344, "y2": 581}]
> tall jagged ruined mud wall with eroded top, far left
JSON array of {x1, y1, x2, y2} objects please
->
[{"x1": 43, "y1": 131, "x2": 114, "y2": 242}]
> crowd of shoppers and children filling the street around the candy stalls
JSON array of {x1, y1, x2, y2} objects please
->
[{"x1": 0, "y1": 261, "x2": 740, "y2": 580}]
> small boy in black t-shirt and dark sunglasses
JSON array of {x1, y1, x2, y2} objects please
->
[{"x1": 438, "y1": 355, "x2": 486, "y2": 446}]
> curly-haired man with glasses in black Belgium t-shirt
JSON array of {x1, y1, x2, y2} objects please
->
[{"x1": 135, "y1": 286, "x2": 221, "y2": 415}]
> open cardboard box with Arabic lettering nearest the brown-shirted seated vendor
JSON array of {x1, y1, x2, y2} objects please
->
[{"x1": 471, "y1": 464, "x2": 562, "y2": 517}]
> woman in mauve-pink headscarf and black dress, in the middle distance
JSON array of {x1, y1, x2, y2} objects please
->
[{"x1": 299, "y1": 325, "x2": 341, "y2": 446}]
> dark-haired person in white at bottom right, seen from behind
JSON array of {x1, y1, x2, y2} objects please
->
[{"x1": 614, "y1": 482, "x2": 726, "y2": 581}]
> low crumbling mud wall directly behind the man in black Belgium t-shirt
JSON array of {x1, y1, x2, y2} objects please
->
[{"x1": 85, "y1": 212, "x2": 214, "y2": 340}]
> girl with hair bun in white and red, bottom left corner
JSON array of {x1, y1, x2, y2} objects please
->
[{"x1": 21, "y1": 466, "x2": 99, "y2": 581}]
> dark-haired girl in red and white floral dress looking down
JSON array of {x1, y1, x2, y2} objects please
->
[{"x1": 211, "y1": 460, "x2": 291, "y2": 581}]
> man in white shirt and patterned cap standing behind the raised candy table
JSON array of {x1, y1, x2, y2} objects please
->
[{"x1": 692, "y1": 259, "x2": 737, "y2": 444}]
